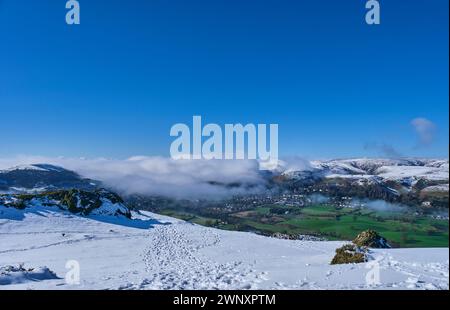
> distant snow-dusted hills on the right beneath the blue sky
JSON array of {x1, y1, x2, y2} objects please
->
[{"x1": 275, "y1": 158, "x2": 449, "y2": 209}]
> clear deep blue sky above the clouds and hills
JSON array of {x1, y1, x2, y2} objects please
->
[{"x1": 0, "y1": 0, "x2": 449, "y2": 158}]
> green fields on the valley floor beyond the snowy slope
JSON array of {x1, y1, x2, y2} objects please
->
[{"x1": 157, "y1": 205, "x2": 449, "y2": 247}]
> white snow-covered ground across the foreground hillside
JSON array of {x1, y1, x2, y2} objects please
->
[{"x1": 0, "y1": 206, "x2": 449, "y2": 289}]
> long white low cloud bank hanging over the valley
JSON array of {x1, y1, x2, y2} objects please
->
[{"x1": 0, "y1": 156, "x2": 266, "y2": 199}]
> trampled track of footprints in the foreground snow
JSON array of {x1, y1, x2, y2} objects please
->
[{"x1": 132, "y1": 223, "x2": 265, "y2": 289}]
